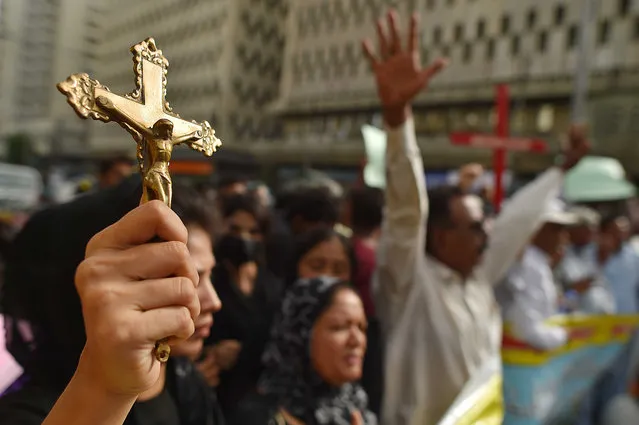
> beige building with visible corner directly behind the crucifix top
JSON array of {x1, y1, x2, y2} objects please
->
[{"x1": 90, "y1": 0, "x2": 288, "y2": 153}]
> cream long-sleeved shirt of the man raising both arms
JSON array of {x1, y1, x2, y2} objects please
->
[{"x1": 374, "y1": 120, "x2": 563, "y2": 425}]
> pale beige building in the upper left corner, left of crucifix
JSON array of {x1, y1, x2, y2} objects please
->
[{"x1": 0, "y1": 0, "x2": 99, "y2": 154}]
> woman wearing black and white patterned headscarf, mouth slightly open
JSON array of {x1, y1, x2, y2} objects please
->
[{"x1": 260, "y1": 278, "x2": 377, "y2": 425}]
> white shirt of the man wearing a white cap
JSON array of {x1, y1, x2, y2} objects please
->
[{"x1": 504, "y1": 246, "x2": 568, "y2": 350}]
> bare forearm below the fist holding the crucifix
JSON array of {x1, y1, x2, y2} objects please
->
[{"x1": 43, "y1": 362, "x2": 136, "y2": 425}]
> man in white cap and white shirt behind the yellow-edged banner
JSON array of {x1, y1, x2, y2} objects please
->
[{"x1": 505, "y1": 199, "x2": 577, "y2": 350}]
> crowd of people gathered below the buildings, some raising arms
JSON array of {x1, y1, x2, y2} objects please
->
[{"x1": 0, "y1": 12, "x2": 639, "y2": 425}]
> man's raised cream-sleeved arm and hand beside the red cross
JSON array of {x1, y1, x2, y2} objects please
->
[{"x1": 482, "y1": 126, "x2": 590, "y2": 284}]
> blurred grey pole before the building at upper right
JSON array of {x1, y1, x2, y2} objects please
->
[{"x1": 571, "y1": 0, "x2": 597, "y2": 122}]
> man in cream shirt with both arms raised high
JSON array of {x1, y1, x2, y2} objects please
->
[{"x1": 364, "y1": 12, "x2": 588, "y2": 425}]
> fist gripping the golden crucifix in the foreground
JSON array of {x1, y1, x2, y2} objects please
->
[{"x1": 76, "y1": 201, "x2": 200, "y2": 396}]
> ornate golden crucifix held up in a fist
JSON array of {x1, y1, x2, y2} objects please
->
[{"x1": 57, "y1": 38, "x2": 222, "y2": 362}]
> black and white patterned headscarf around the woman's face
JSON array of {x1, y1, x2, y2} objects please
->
[{"x1": 260, "y1": 278, "x2": 377, "y2": 425}]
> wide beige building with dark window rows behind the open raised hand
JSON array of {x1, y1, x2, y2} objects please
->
[{"x1": 268, "y1": 0, "x2": 639, "y2": 172}]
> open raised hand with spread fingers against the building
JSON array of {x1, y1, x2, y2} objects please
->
[{"x1": 362, "y1": 10, "x2": 447, "y2": 126}]
